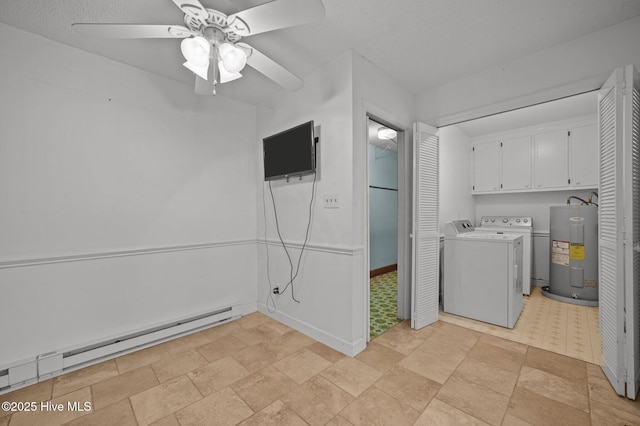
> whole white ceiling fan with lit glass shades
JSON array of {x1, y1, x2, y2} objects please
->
[{"x1": 72, "y1": 0, "x2": 324, "y2": 95}]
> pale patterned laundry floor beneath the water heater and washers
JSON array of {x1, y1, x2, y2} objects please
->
[{"x1": 439, "y1": 287, "x2": 602, "y2": 365}]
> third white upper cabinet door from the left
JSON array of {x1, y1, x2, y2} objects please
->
[{"x1": 533, "y1": 130, "x2": 569, "y2": 189}]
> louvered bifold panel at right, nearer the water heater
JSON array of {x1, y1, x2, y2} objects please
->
[{"x1": 598, "y1": 69, "x2": 624, "y2": 395}]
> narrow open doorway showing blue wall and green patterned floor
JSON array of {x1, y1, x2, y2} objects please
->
[{"x1": 367, "y1": 116, "x2": 404, "y2": 339}]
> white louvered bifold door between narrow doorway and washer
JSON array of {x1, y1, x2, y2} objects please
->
[{"x1": 411, "y1": 123, "x2": 440, "y2": 329}]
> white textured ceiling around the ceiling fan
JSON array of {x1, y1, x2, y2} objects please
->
[{"x1": 0, "y1": 0, "x2": 640, "y2": 104}]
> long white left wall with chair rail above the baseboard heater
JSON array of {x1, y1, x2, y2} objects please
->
[{"x1": 0, "y1": 24, "x2": 257, "y2": 366}]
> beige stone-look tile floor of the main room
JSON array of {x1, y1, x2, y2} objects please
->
[{"x1": 0, "y1": 313, "x2": 640, "y2": 426}]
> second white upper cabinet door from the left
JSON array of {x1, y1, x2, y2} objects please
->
[{"x1": 501, "y1": 136, "x2": 531, "y2": 191}]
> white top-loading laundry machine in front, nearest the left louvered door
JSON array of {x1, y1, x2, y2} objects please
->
[{"x1": 443, "y1": 220, "x2": 524, "y2": 328}]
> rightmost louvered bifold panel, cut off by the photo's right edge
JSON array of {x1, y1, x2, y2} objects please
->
[{"x1": 623, "y1": 65, "x2": 640, "y2": 399}]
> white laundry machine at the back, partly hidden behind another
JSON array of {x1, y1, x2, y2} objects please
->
[{"x1": 476, "y1": 216, "x2": 533, "y2": 295}]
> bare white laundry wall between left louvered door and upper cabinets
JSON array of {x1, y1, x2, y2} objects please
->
[{"x1": 438, "y1": 126, "x2": 476, "y2": 232}]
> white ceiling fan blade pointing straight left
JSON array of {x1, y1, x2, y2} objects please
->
[{"x1": 71, "y1": 24, "x2": 191, "y2": 38}]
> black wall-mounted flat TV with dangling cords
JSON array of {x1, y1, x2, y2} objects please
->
[{"x1": 262, "y1": 121, "x2": 316, "y2": 180}]
